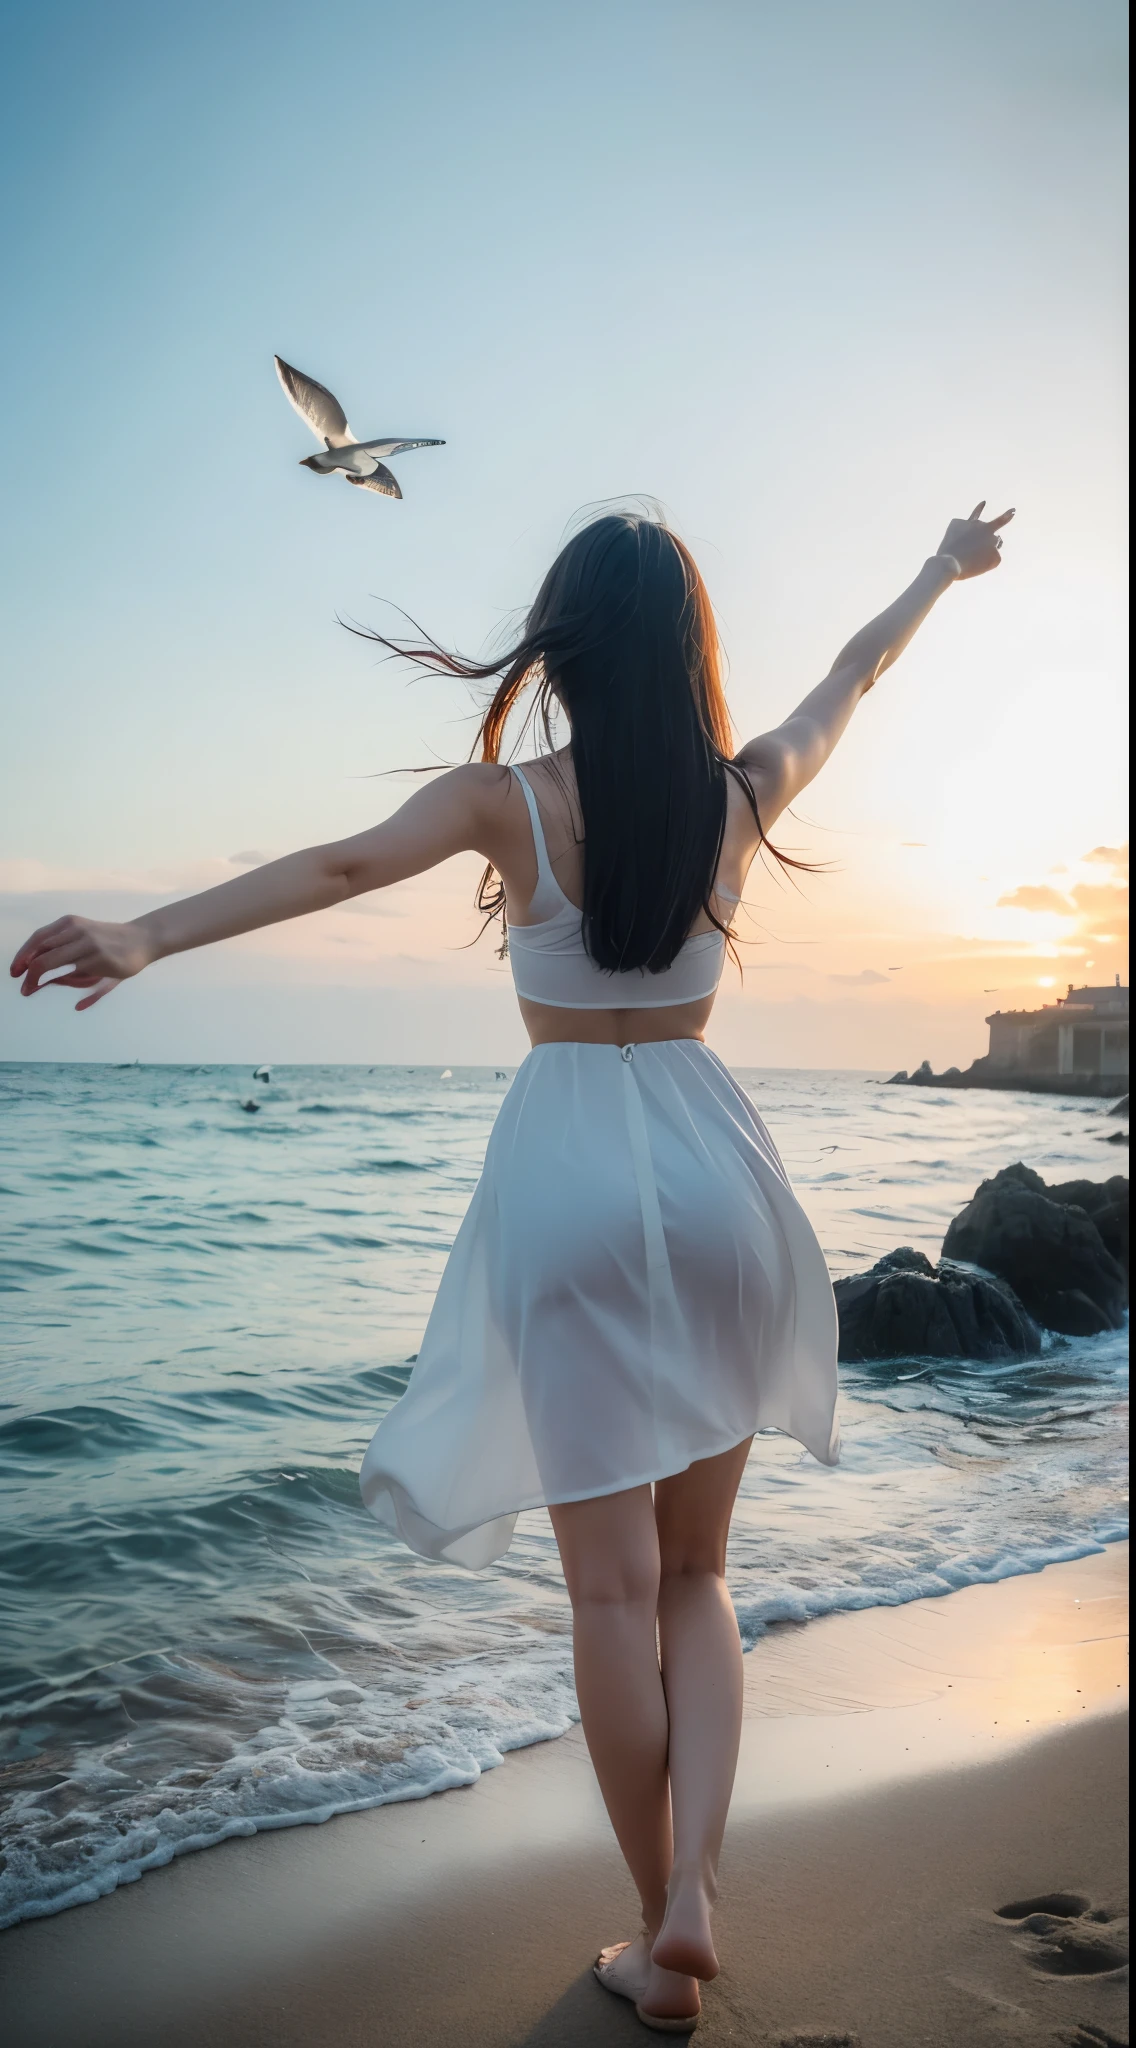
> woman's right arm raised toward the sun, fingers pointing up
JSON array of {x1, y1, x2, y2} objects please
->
[{"x1": 737, "y1": 504, "x2": 1013, "y2": 829}]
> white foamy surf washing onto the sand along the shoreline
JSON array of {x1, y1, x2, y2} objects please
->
[{"x1": 0, "y1": 1520, "x2": 1128, "y2": 1929}]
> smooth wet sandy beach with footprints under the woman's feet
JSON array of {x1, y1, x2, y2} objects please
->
[{"x1": 0, "y1": 1544, "x2": 1128, "y2": 2048}]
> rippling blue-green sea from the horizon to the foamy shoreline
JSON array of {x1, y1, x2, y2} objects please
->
[{"x1": 0, "y1": 1065, "x2": 1128, "y2": 1925}]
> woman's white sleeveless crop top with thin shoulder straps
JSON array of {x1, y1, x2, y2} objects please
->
[{"x1": 510, "y1": 768, "x2": 737, "y2": 1010}]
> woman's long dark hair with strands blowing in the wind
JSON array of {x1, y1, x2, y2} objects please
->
[{"x1": 356, "y1": 512, "x2": 804, "y2": 973}]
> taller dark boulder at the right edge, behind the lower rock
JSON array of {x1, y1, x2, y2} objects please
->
[{"x1": 944, "y1": 1161, "x2": 1128, "y2": 1337}]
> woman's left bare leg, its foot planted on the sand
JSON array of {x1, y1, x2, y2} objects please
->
[{"x1": 549, "y1": 1487, "x2": 698, "y2": 2017}]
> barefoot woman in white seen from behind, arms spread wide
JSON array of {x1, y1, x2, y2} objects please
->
[{"x1": 12, "y1": 506, "x2": 1011, "y2": 2034}]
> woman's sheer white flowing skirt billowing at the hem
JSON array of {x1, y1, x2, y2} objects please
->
[{"x1": 360, "y1": 1038, "x2": 839, "y2": 1571}]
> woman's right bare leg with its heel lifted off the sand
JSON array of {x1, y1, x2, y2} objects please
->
[{"x1": 651, "y1": 1440, "x2": 751, "y2": 1978}]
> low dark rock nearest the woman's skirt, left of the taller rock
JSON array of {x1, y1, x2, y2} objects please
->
[{"x1": 833, "y1": 1245, "x2": 1042, "y2": 1364}]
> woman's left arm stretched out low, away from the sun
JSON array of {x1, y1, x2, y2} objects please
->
[{"x1": 10, "y1": 764, "x2": 506, "y2": 1010}]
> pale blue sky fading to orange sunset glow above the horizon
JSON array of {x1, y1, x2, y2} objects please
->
[{"x1": 0, "y1": 0, "x2": 1128, "y2": 1069}]
